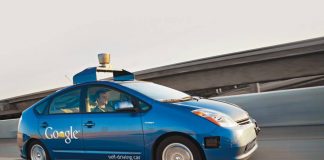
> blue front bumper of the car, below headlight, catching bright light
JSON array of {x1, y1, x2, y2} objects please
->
[{"x1": 204, "y1": 123, "x2": 259, "y2": 160}]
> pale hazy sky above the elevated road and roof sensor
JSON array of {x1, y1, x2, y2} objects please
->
[{"x1": 0, "y1": 0, "x2": 324, "y2": 99}]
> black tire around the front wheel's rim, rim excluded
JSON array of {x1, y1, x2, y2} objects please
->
[{"x1": 154, "y1": 136, "x2": 204, "y2": 160}]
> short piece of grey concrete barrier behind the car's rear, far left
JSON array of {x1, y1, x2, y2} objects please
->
[{"x1": 0, "y1": 119, "x2": 19, "y2": 138}]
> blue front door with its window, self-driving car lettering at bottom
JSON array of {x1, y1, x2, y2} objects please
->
[{"x1": 82, "y1": 85, "x2": 144, "y2": 160}]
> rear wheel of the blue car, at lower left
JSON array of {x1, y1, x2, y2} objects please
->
[{"x1": 27, "y1": 141, "x2": 50, "y2": 160}]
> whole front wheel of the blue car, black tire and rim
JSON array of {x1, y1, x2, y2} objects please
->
[{"x1": 155, "y1": 136, "x2": 203, "y2": 160}]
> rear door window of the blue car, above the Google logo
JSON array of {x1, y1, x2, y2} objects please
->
[{"x1": 49, "y1": 89, "x2": 81, "y2": 114}]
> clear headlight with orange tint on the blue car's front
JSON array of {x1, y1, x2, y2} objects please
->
[{"x1": 191, "y1": 109, "x2": 237, "y2": 127}]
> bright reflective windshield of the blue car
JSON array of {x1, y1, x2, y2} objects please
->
[{"x1": 122, "y1": 82, "x2": 192, "y2": 102}]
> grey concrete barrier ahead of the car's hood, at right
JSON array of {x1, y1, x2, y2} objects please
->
[{"x1": 211, "y1": 86, "x2": 324, "y2": 127}]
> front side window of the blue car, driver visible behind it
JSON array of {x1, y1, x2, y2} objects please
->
[{"x1": 86, "y1": 86, "x2": 149, "y2": 113}]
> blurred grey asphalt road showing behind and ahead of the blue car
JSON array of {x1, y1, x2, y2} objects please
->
[{"x1": 0, "y1": 125, "x2": 324, "y2": 160}]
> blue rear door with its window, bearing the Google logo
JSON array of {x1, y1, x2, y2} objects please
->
[{"x1": 38, "y1": 88, "x2": 83, "y2": 159}]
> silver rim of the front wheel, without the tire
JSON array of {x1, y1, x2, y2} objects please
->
[{"x1": 162, "y1": 143, "x2": 193, "y2": 160}]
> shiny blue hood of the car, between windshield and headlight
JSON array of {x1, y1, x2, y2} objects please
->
[{"x1": 174, "y1": 99, "x2": 249, "y2": 121}]
